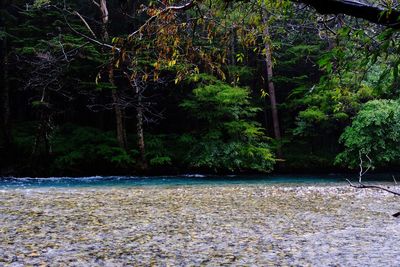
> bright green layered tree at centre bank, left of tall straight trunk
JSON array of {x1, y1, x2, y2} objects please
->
[{"x1": 180, "y1": 78, "x2": 275, "y2": 172}]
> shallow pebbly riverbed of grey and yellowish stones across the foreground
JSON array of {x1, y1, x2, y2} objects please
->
[{"x1": 0, "y1": 185, "x2": 400, "y2": 266}]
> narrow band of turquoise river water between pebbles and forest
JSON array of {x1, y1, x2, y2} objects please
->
[{"x1": 0, "y1": 174, "x2": 392, "y2": 189}]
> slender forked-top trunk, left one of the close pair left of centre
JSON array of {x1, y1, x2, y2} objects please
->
[{"x1": 98, "y1": 0, "x2": 128, "y2": 150}]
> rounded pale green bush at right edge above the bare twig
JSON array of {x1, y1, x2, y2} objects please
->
[{"x1": 336, "y1": 100, "x2": 400, "y2": 168}]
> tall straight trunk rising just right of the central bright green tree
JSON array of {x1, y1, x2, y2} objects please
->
[{"x1": 262, "y1": 11, "x2": 282, "y2": 157}]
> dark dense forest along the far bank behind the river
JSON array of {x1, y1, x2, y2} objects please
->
[{"x1": 0, "y1": 0, "x2": 400, "y2": 176}]
